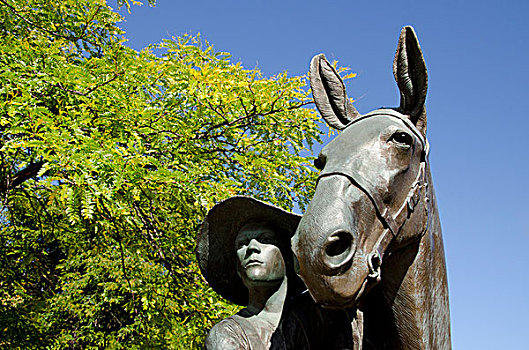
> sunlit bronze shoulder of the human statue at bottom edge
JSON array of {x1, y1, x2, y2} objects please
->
[{"x1": 206, "y1": 316, "x2": 251, "y2": 350}]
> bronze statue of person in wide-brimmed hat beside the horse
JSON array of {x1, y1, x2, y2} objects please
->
[{"x1": 197, "y1": 196, "x2": 359, "y2": 350}]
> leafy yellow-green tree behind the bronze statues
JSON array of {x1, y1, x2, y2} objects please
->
[{"x1": 0, "y1": 0, "x2": 319, "y2": 349}]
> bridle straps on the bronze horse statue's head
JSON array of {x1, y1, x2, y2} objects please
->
[{"x1": 316, "y1": 109, "x2": 429, "y2": 291}]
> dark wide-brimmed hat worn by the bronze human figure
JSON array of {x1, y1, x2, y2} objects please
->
[{"x1": 196, "y1": 196, "x2": 301, "y2": 306}]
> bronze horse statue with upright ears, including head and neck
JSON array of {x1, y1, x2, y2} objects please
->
[{"x1": 292, "y1": 27, "x2": 451, "y2": 349}]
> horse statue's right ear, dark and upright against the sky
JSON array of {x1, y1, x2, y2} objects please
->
[{"x1": 393, "y1": 26, "x2": 428, "y2": 135}]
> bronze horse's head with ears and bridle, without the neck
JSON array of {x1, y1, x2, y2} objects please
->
[{"x1": 292, "y1": 27, "x2": 430, "y2": 308}]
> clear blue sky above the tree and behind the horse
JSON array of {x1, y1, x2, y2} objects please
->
[{"x1": 114, "y1": 0, "x2": 529, "y2": 349}]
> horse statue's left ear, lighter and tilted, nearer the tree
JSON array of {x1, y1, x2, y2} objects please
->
[{"x1": 309, "y1": 54, "x2": 360, "y2": 130}]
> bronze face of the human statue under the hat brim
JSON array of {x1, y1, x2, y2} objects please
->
[{"x1": 235, "y1": 225, "x2": 286, "y2": 287}]
